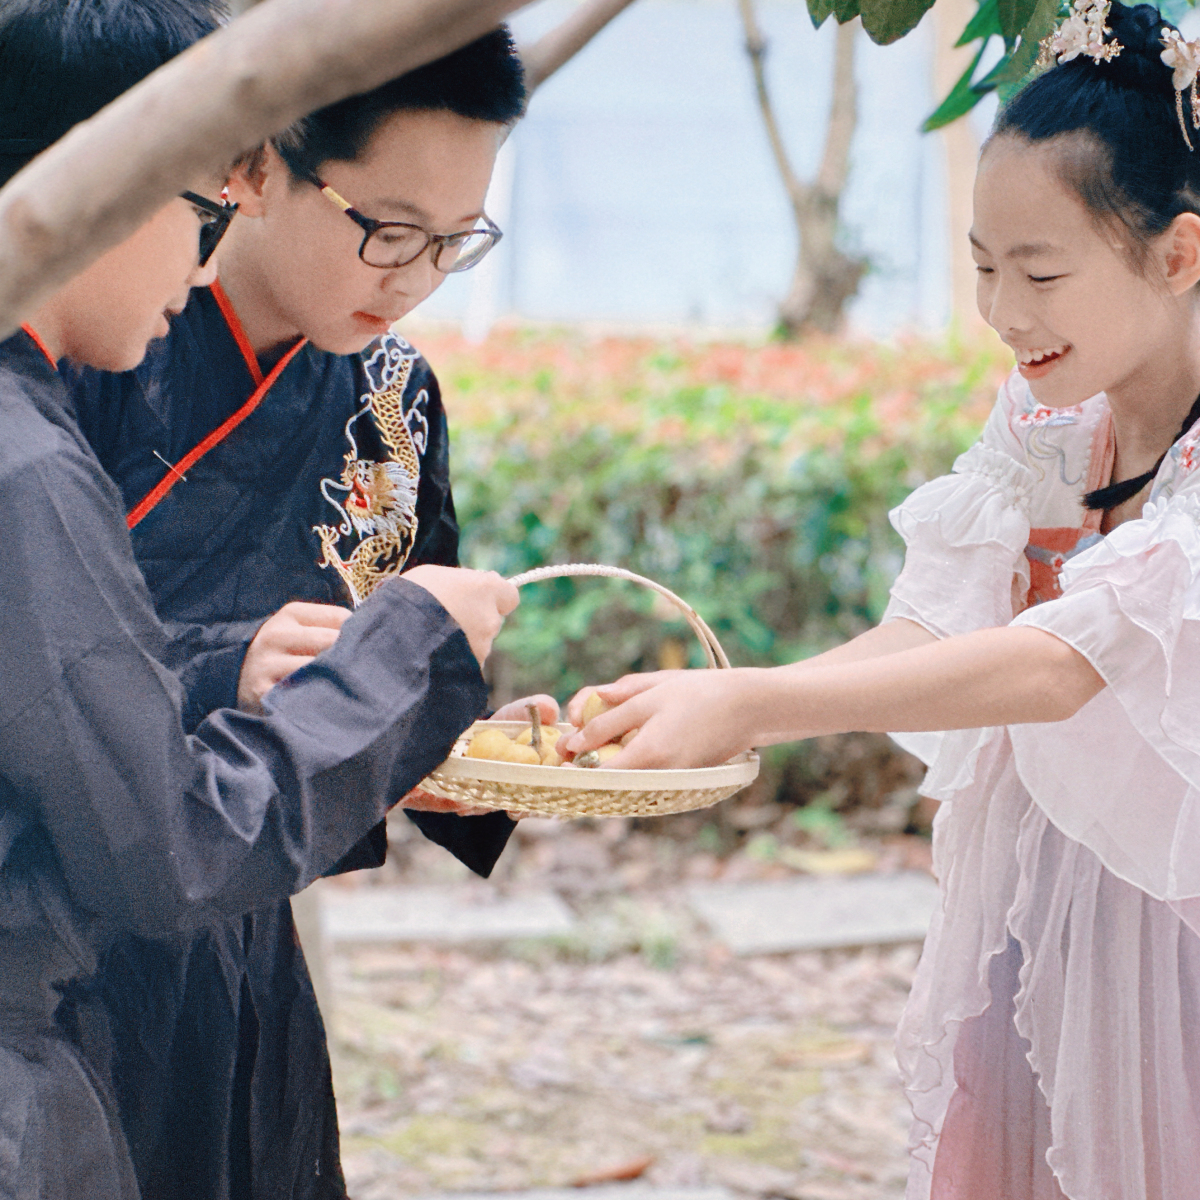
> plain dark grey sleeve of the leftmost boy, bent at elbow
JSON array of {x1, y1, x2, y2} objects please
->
[{"x1": 0, "y1": 412, "x2": 486, "y2": 936}]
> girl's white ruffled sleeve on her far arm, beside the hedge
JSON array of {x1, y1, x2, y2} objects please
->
[{"x1": 883, "y1": 391, "x2": 1034, "y2": 637}]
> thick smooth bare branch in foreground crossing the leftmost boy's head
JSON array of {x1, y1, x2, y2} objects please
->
[{"x1": 0, "y1": 0, "x2": 527, "y2": 338}]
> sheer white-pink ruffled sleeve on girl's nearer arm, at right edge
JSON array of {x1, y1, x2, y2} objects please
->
[{"x1": 1009, "y1": 487, "x2": 1200, "y2": 901}]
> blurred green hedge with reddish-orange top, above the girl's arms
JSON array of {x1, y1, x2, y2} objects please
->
[{"x1": 427, "y1": 335, "x2": 1004, "y2": 703}]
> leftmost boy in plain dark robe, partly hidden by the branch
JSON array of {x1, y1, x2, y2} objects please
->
[{"x1": 0, "y1": 0, "x2": 516, "y2": 1200}]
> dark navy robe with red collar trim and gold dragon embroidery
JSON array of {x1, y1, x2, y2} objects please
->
[{"x1": 65, "y1": 290, "x2": 512, "y2": 1200}]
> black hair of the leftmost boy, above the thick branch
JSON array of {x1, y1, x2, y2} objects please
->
[{"x1": 0, "y1": 0, "x2": 228, "y2": 184}]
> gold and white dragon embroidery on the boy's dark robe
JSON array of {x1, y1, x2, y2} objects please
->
[{"x1": 313, "y1": 334, "x2": 430, "y2": 606}]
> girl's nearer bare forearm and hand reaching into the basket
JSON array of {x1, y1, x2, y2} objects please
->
[{"x1": 569, "y1": 623, "x2": 1104, "y2": 767}]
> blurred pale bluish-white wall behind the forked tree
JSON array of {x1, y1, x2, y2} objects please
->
[{"x1": 422, "y1": 0, "x2": 950, "y2": 336}]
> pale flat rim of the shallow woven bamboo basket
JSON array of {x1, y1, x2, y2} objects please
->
[{"x1": 430, "y1": 721, "x2": 760, "y2": 792}]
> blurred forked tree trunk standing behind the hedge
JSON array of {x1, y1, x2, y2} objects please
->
[{"x1": 738, "y1": 0, "x2": 866, "y2": 337}]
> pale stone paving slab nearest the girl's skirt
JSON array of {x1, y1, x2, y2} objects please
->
[{"x1": 686, "y1": 871, "x2": 937, "y2": 954}]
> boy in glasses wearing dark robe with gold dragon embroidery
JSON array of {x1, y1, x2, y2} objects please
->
[{"x1": 64, "y1": 23, "x2": 535, "y2": 1200}]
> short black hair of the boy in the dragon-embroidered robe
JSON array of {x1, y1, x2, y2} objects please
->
[{"x1": 271, "y1": 26, "x2": 526, "y2": 179}]
